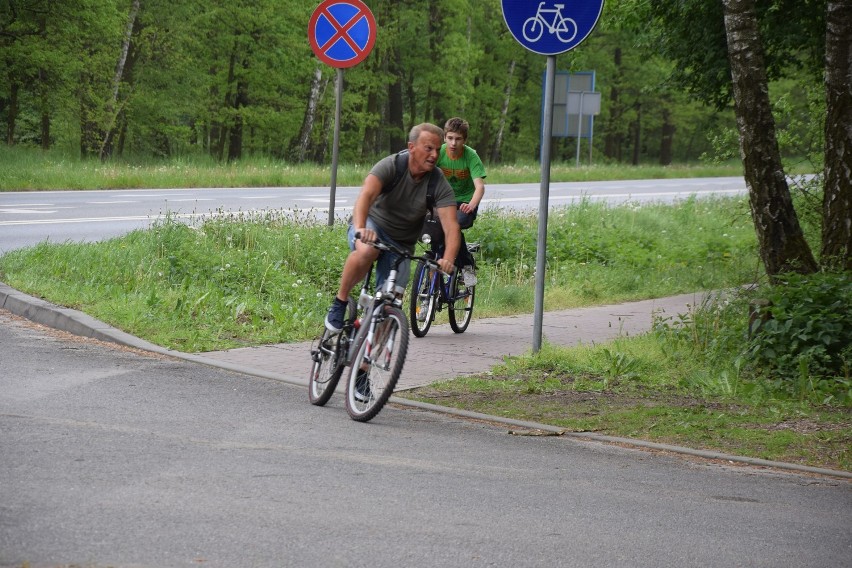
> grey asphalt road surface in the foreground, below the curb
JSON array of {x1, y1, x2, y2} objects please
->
[{"x1": 0, "y1": 310, "x2": 852, "y2": 568}]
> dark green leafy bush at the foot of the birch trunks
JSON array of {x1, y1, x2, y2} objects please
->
[{"x1": 749, "y1": 272, "x2": 852, "y2": 401}]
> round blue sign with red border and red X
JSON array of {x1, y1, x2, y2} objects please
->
[{"x1": 308, "y1": 0, "x2": 376, "y2": 67}]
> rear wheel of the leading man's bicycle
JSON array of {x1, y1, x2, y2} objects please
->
[{"x1": 308, "y1": 299, "x2": 357, "y2": 406}]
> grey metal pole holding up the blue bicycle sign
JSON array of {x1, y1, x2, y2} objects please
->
[{"x1": 533, "y1": 55, "x2": 556, "y2": 353}]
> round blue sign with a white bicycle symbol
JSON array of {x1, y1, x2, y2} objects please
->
[{"x1": 501, "y1": 0, "x2": 604, "y2": 55}]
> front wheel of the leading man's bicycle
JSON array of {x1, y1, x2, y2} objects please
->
[{"x1": 346, "y1": 305, "x2": 408, "y2": 422}]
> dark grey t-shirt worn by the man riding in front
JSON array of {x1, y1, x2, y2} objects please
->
[{"x1": 369, "y1": 154, "x2": 456, "y2": 247}]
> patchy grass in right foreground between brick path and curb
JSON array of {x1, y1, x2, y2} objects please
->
[{"x1": 401, "y1": 334, "x2": 852, "y2": 471}]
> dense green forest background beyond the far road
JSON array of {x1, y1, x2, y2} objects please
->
[{"x1": 0, "y1": 0, "x2": 824, "y2": 164}]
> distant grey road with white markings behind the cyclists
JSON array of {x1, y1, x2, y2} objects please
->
[{"x1": 0, "y1": 177, "x2": 746, "y2": 254}]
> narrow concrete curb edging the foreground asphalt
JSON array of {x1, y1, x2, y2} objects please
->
[{"x1": 0, "y1": 282, "x2": 852, "y2": 480}]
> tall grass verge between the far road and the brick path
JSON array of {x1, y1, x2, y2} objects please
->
[{"x1": 0, "y1": 199, "x2": 757, "y2": 352}]
